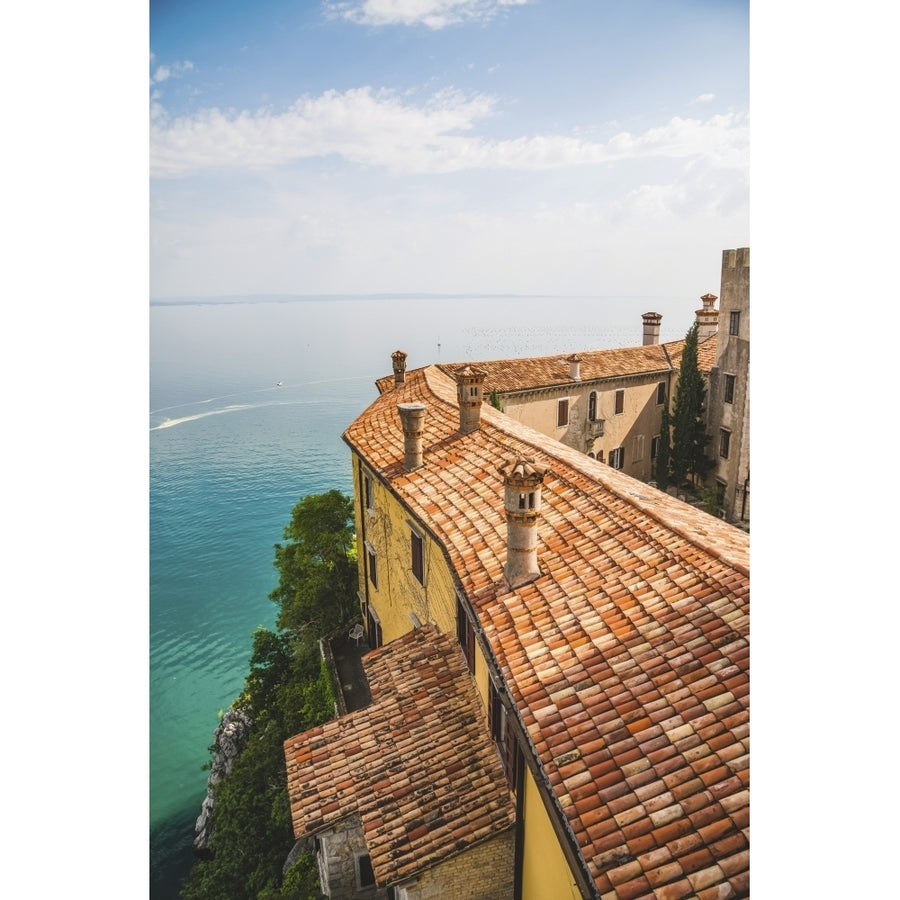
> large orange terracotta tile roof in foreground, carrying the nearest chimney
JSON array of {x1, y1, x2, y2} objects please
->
[{"x1": 345, "y1": 368, "x2": 749, "y2": 898}]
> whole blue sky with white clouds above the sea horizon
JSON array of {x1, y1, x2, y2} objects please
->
[{"x1": 149, "y1": 0, "x2": 750, "y2": 298}]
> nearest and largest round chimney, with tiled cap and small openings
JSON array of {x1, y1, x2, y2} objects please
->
[{"x1": 497, "y1": 456, "x2": 550, "y2": 588}]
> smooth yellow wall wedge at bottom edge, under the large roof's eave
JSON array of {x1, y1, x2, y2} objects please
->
[{"x1": 522, "y1": 770, "x2": 581, "y2": 900}]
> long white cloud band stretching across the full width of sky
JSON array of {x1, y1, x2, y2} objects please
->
[{"x1": 150, "y1": 87, "x2": 749, "y2": 178}]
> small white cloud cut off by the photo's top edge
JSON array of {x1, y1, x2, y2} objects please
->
[{"x1": 326, "y1": 0, "x2": 531, "y2": 30}]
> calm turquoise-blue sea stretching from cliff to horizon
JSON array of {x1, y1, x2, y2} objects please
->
[{"x1": 149, "y1": 296, "x2": 699, "y2": 900}]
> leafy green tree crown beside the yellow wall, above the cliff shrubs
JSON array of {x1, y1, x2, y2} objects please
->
[{"x1": 269, "y1": 491, "x2": 357, "y2": 639}]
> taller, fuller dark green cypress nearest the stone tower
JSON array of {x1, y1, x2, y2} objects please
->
[{"x1": 670, "y1": 322, "x2": 712, "y2": 486}]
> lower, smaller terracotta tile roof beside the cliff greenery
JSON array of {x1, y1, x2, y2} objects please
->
[{"x1": 284, "y1": 625, "x2": 515, "y2": 886}]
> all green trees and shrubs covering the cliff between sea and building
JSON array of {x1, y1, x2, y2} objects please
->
[{"x1": 181, "y1": 491, "x2": 356, "y2": 900}]
